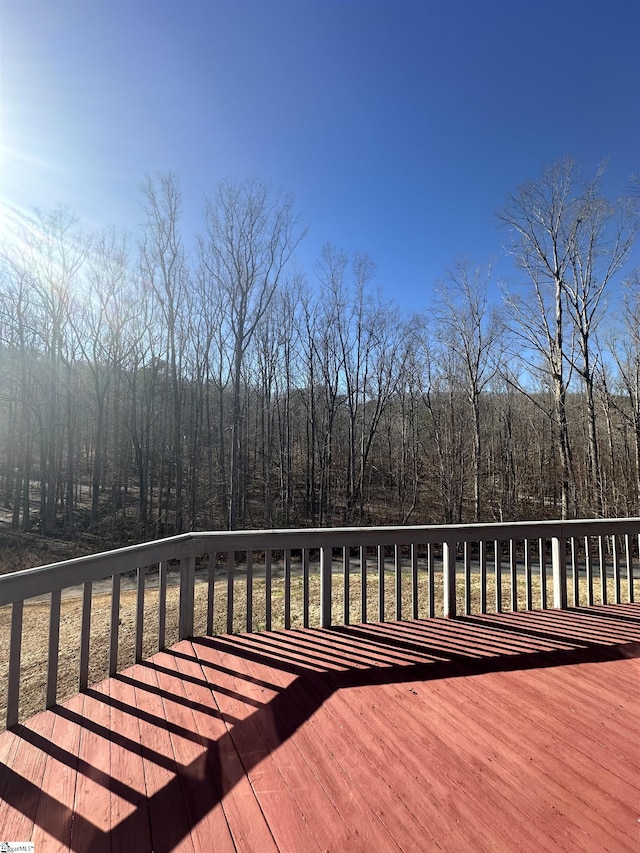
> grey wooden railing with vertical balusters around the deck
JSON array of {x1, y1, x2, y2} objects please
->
[{"x1": 0, "y1": 518, "x2": 640, "y2": 727}]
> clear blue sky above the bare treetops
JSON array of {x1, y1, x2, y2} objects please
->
[{"x1": 0, "y1": 0, "x2": 640, "y2": 309}]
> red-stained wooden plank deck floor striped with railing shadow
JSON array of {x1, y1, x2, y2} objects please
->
[{"x1": 0, "y1": 604, "x2": 640, "y2": 853}]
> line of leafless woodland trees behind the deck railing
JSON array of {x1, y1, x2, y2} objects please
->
[{"x1": 0, "y1": 161, "x2": 640, "y2": 542}]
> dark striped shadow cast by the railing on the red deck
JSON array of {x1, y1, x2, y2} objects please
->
[{"x1": 0, "y1": 605, "x2": 640, "y2": 853}]
